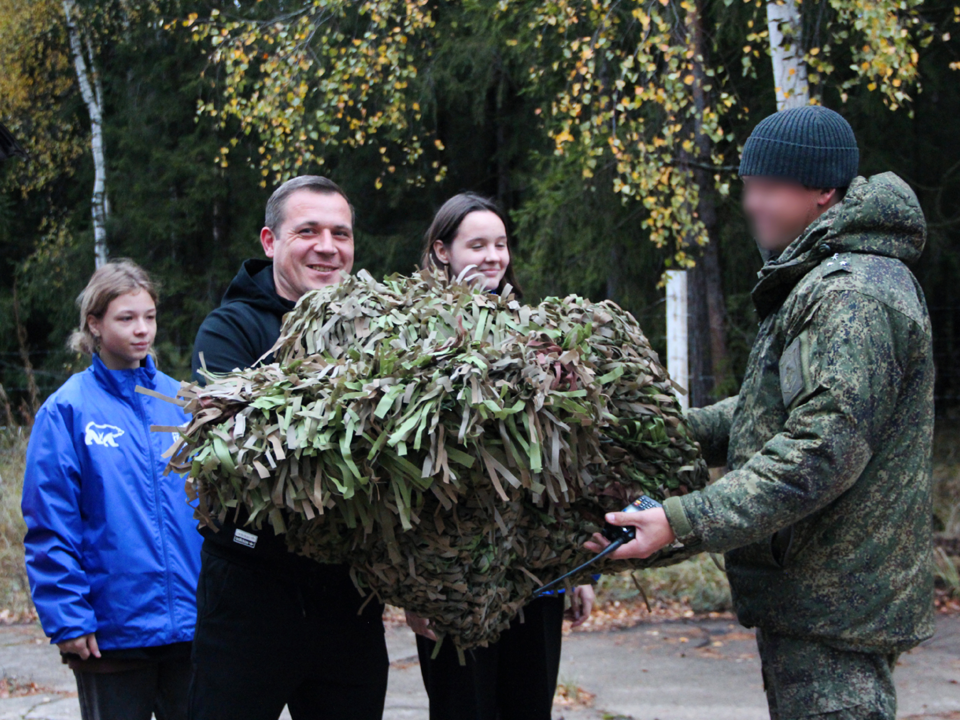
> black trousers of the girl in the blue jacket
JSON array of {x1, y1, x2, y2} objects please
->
[{"x1": 73, "y1": 658, "x2": 190, "y2": 720}]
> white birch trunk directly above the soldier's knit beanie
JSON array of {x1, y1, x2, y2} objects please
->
[{"x1": 767, "y1": 0, "x2": 810, "y2": 110}]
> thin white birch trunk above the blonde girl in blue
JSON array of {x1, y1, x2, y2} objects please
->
[{"x1": 63, "y1": 0, "x2": 110, "y2": 268}]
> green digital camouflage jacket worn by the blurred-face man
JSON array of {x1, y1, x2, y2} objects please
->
[{"x1": 665, "y1": 173, "x2": 934, "y2": 652}]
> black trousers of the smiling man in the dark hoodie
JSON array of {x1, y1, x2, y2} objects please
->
[{"x1": 189, "y1": 541, "x2": 389, "y2": 720}]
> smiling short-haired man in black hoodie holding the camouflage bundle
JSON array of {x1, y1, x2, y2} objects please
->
[{"x1": 190, "y1": 176, "x2": 388, "y2": 720}]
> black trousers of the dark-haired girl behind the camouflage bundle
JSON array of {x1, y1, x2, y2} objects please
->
[{"x1": 417, "y1": 595, "x2": 564, "y2": 720}]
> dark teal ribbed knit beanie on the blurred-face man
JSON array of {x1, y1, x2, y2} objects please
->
[{"x1": 740, "y1": 105, "x2": 860, "y2": 188}]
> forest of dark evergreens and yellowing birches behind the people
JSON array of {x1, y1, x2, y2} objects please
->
[{"x1": 0, "y1": 0, "x2": 960, "y2": 416}]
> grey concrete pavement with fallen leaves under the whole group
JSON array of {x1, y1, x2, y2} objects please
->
[{"x1": 0, "y1": 616, "x2": 960, "y2": 720}]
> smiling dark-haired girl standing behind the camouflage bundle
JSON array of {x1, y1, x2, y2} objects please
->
[{"x1": 407, "y1": 193, "x2": 594, "y2": 720}]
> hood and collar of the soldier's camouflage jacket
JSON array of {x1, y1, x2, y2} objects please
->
[{"x1": 753, "y1": 172, "x2": 927, "y2": 319}]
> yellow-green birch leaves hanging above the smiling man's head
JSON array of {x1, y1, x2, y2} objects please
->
[{"x1": 182, "y1": 0, "x2": 444, "y2": 187}]
